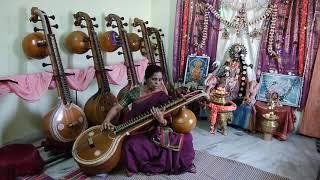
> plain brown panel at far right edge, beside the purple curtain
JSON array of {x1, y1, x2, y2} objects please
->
[{"x1": 300, "y1": 48, "x2": 320, "y2": 138}]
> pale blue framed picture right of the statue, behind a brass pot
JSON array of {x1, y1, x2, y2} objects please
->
[{"x1": 257, "y1": 73, "x2": 303, "y2": 107}]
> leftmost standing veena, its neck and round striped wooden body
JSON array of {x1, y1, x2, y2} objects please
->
[{"x1": 30, "y1": 7, "x2": 88, "y2": 142}]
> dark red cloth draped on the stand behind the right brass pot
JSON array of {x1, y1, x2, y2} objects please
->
[{"x1": 255, "y1": 101, "x2": 296, "y2": 141}]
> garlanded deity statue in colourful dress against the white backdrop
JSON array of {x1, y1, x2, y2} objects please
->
[{"x1": 205, "y1": 43, "x2": 259, "y2": 132}]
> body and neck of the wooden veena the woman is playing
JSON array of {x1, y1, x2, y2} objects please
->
[{"x1": 72, "y1": 91, "x2": 208, "y2": 175}]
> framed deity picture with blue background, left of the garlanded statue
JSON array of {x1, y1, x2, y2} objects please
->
[{"x1": 183, "y1": 55, "x2": 210, "y2": 88}]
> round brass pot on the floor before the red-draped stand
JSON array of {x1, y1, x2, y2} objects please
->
[{"x1": 261, "y1": 113, "x2": 279, "y2": 134}]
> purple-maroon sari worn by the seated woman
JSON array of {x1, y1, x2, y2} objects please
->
[{"x1": 123, "y1": 91, "x2": 195, "y2": 174}]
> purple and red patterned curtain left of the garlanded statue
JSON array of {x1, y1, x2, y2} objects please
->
[{"x1": 172, "y1": 0, "x2": 220, "y2": 82}]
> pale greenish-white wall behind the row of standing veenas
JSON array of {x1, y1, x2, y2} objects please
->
[{"x1": 0, "y1": 0, "x2": 164, "y2": 145}]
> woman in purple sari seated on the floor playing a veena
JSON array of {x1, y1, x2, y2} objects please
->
[{"x1": 103, "y1": 65, "x2": 195, "y2": 176}]
